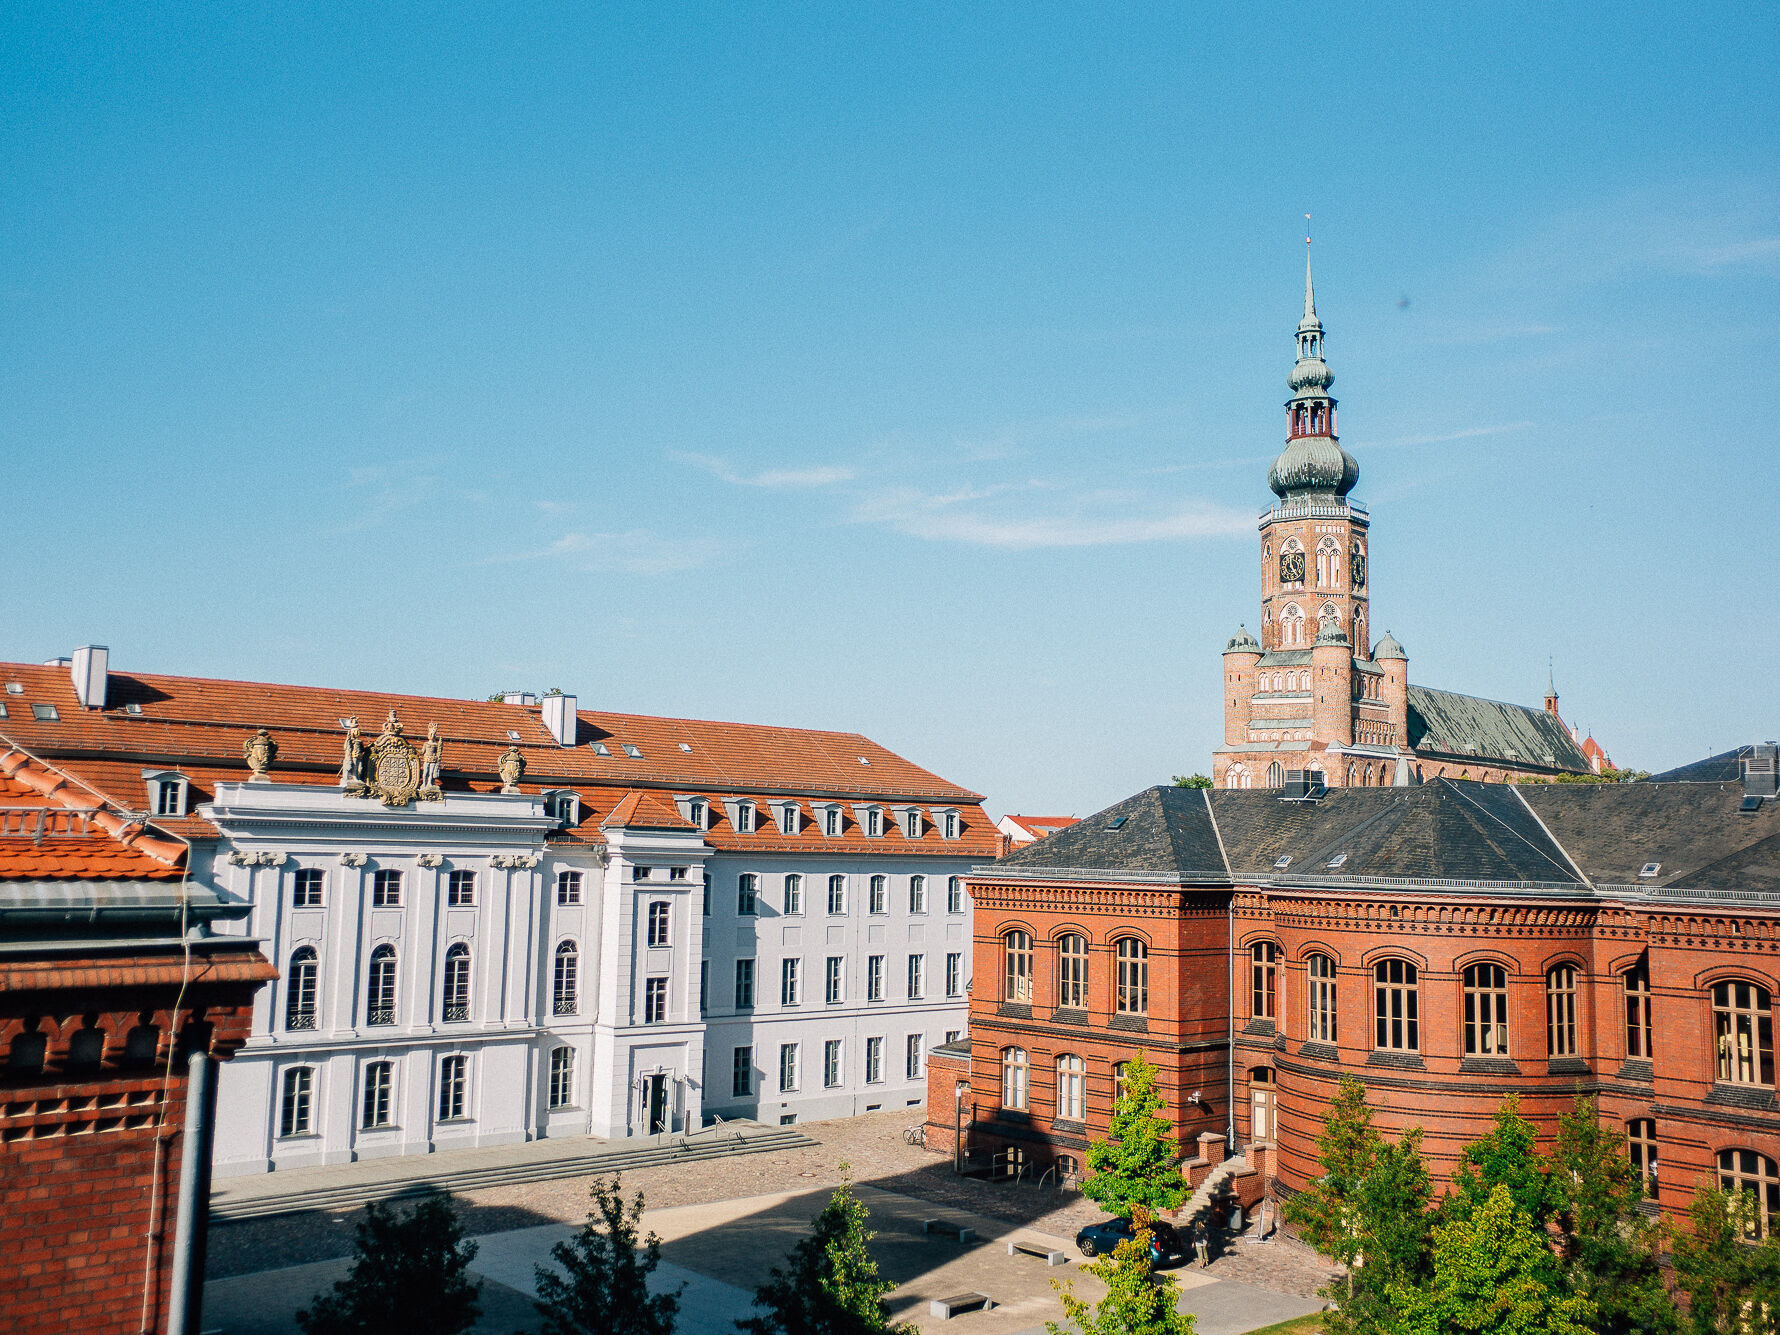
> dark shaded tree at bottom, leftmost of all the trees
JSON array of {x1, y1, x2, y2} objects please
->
[{"x1": 297, "y1": 1196, "x2": 482, "y2": 1335}]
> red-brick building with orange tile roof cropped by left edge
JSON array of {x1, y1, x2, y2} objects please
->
[{"x1": 0, "y1": 737, "x2": 272, "y2": 1335}]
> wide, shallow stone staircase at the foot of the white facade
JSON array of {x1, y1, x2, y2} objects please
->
[{"x1": 210, "y1": 1121, "x2": 815, "y2": 1223}]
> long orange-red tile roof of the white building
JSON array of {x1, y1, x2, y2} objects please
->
[{"x1": 0, "y1": 664, "x2": 997, "y2": 858}]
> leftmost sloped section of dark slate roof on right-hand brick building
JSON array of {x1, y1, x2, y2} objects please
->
[{"x1": 995, "y1": 785, "x2": 1228, "y2": 883}]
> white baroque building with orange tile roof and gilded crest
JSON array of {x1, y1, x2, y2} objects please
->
[{"x1": 0, "y1": 648, "x2": 997, "y2": 1175}]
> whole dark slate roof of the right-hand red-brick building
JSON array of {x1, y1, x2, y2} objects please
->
[{"x1": 984, "y1": 780, "x2": 1780, "y2": 895}]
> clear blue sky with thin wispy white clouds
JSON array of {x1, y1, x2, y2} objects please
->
[{"x1": 0, "y1": 4, "x2": 1780, "y2": 813}]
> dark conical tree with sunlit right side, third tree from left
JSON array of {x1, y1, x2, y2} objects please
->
[{"x1": 735, "y1": 1164, "x2": 917, "y2": 1335}]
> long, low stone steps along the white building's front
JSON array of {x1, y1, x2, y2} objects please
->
[{"x1": 210, "y1": 1129, "x2": 815, "y2": 1223}]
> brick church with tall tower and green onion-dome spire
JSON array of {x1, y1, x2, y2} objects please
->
[{"x1": 1212, "y1": 260, "x2": 1598, "y2": 789}]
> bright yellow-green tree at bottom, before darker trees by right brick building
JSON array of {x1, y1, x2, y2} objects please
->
[{"x1": 1385, "y1": 1182, "x2": 1595, "y2": 1335}]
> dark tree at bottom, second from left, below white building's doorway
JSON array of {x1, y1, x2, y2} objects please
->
[{"x1": 532, "y1": 1175, "x2": 680, "y2": 1335}]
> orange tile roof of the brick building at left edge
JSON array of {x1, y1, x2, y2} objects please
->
[{"x1": 0, "y1": 746, "x2": 185, "y2": 881}]
